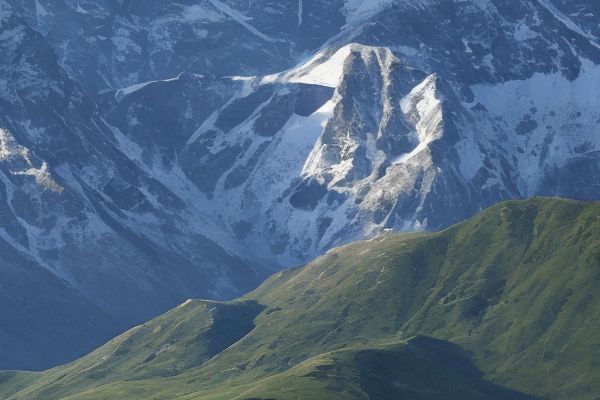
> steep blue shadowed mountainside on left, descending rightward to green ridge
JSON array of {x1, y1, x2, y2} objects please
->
[{"x1": 0, "y1": 4, "x2": 269, "y2": 368}]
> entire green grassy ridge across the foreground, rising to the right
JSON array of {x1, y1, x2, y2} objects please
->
[{"x1": 0, "y1": 198, "x2": 600, "y2": 400}]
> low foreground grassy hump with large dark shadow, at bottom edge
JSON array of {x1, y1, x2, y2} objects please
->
[{"x1": 189, "y1": 337, "x2": 533, "y2": 400}]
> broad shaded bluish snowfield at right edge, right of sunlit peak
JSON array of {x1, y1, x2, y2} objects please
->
[{"x1": 470, "y1": 59, "x2": 600, "y2": 195}]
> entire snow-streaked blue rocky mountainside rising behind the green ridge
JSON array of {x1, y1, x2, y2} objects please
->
[{"x1": 0, "y1": 0, "x2": 600, "y2": 368}]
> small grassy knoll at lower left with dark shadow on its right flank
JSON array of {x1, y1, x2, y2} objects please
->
[{"x1": 0, "y1": 300, "x2": 262, "y2": 398}]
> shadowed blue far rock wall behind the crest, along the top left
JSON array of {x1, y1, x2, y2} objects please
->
[{"x1": 6, "y1": 0, "x2": 345, "y2": 94}]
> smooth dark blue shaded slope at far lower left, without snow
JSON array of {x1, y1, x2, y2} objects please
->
[{"x1": 0, "y1": 239, "x2": 123, "y2": 372}]
